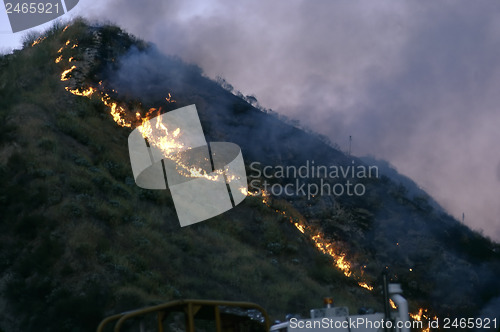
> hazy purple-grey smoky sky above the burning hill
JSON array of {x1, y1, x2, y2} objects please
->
[{"x1": 0, "y1": 0, "x2": 500, "y2": 240}]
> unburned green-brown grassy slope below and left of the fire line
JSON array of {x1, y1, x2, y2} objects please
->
[{"x1": 0, "y1": 21, "x2": 377, "y2": 331}]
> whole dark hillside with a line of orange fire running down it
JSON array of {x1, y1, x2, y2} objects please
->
[{"x1": 0, "y1": 20, "x2": 500, "y2": 331}]
